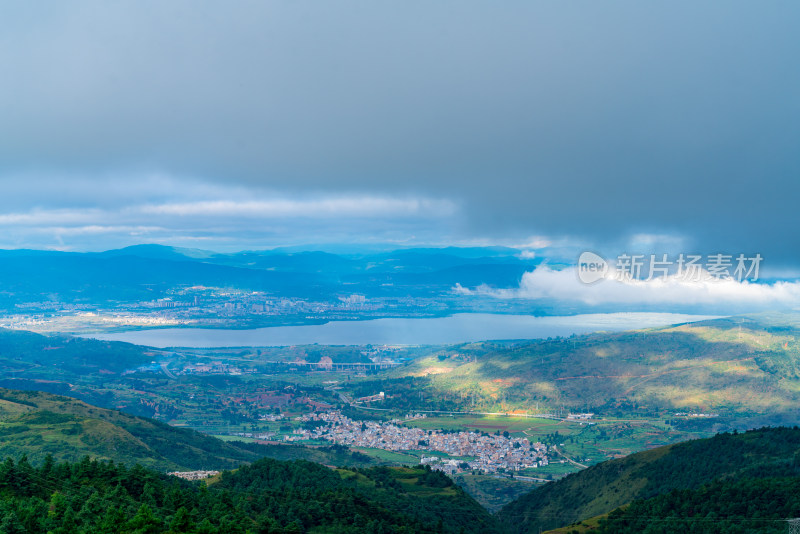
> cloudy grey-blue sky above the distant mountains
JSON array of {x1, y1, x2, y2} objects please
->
[{"x1": 0, "y1": 0, "x2": 800, "y2": 268}]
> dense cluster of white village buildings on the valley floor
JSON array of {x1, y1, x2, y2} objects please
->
[{"x1": 286, "y1": 411, "x2": 548, "y2": 473}]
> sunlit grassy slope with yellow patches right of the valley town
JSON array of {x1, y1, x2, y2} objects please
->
[{"x1": 392, "y1": 315, "x2": 800, "y2": 422}]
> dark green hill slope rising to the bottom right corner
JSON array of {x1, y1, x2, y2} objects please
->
[{"x1": 498, "y1": 427, "x2": 800, "y2": 533}]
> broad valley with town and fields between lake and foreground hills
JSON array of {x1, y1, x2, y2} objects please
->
[{"x1": 0, "y1": 314, "x2": 800, "y2": 520}]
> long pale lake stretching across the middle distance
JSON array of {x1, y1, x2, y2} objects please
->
[{"x1": 83, "y1": 313, "x2": 715, "y2": 348}]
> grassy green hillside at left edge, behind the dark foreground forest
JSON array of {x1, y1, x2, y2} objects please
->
[{"x1": 0, "y1": 388, "x2": 370, "y2": 470}]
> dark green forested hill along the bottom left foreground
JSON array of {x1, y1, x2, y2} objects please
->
[{"x1": 0, "y1": 459, "x2": 499, "y2": 534}]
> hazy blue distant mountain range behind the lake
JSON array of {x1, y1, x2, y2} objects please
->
[{"x1": 0, "y1": 245, "x2": 540, "y2": 307}]
